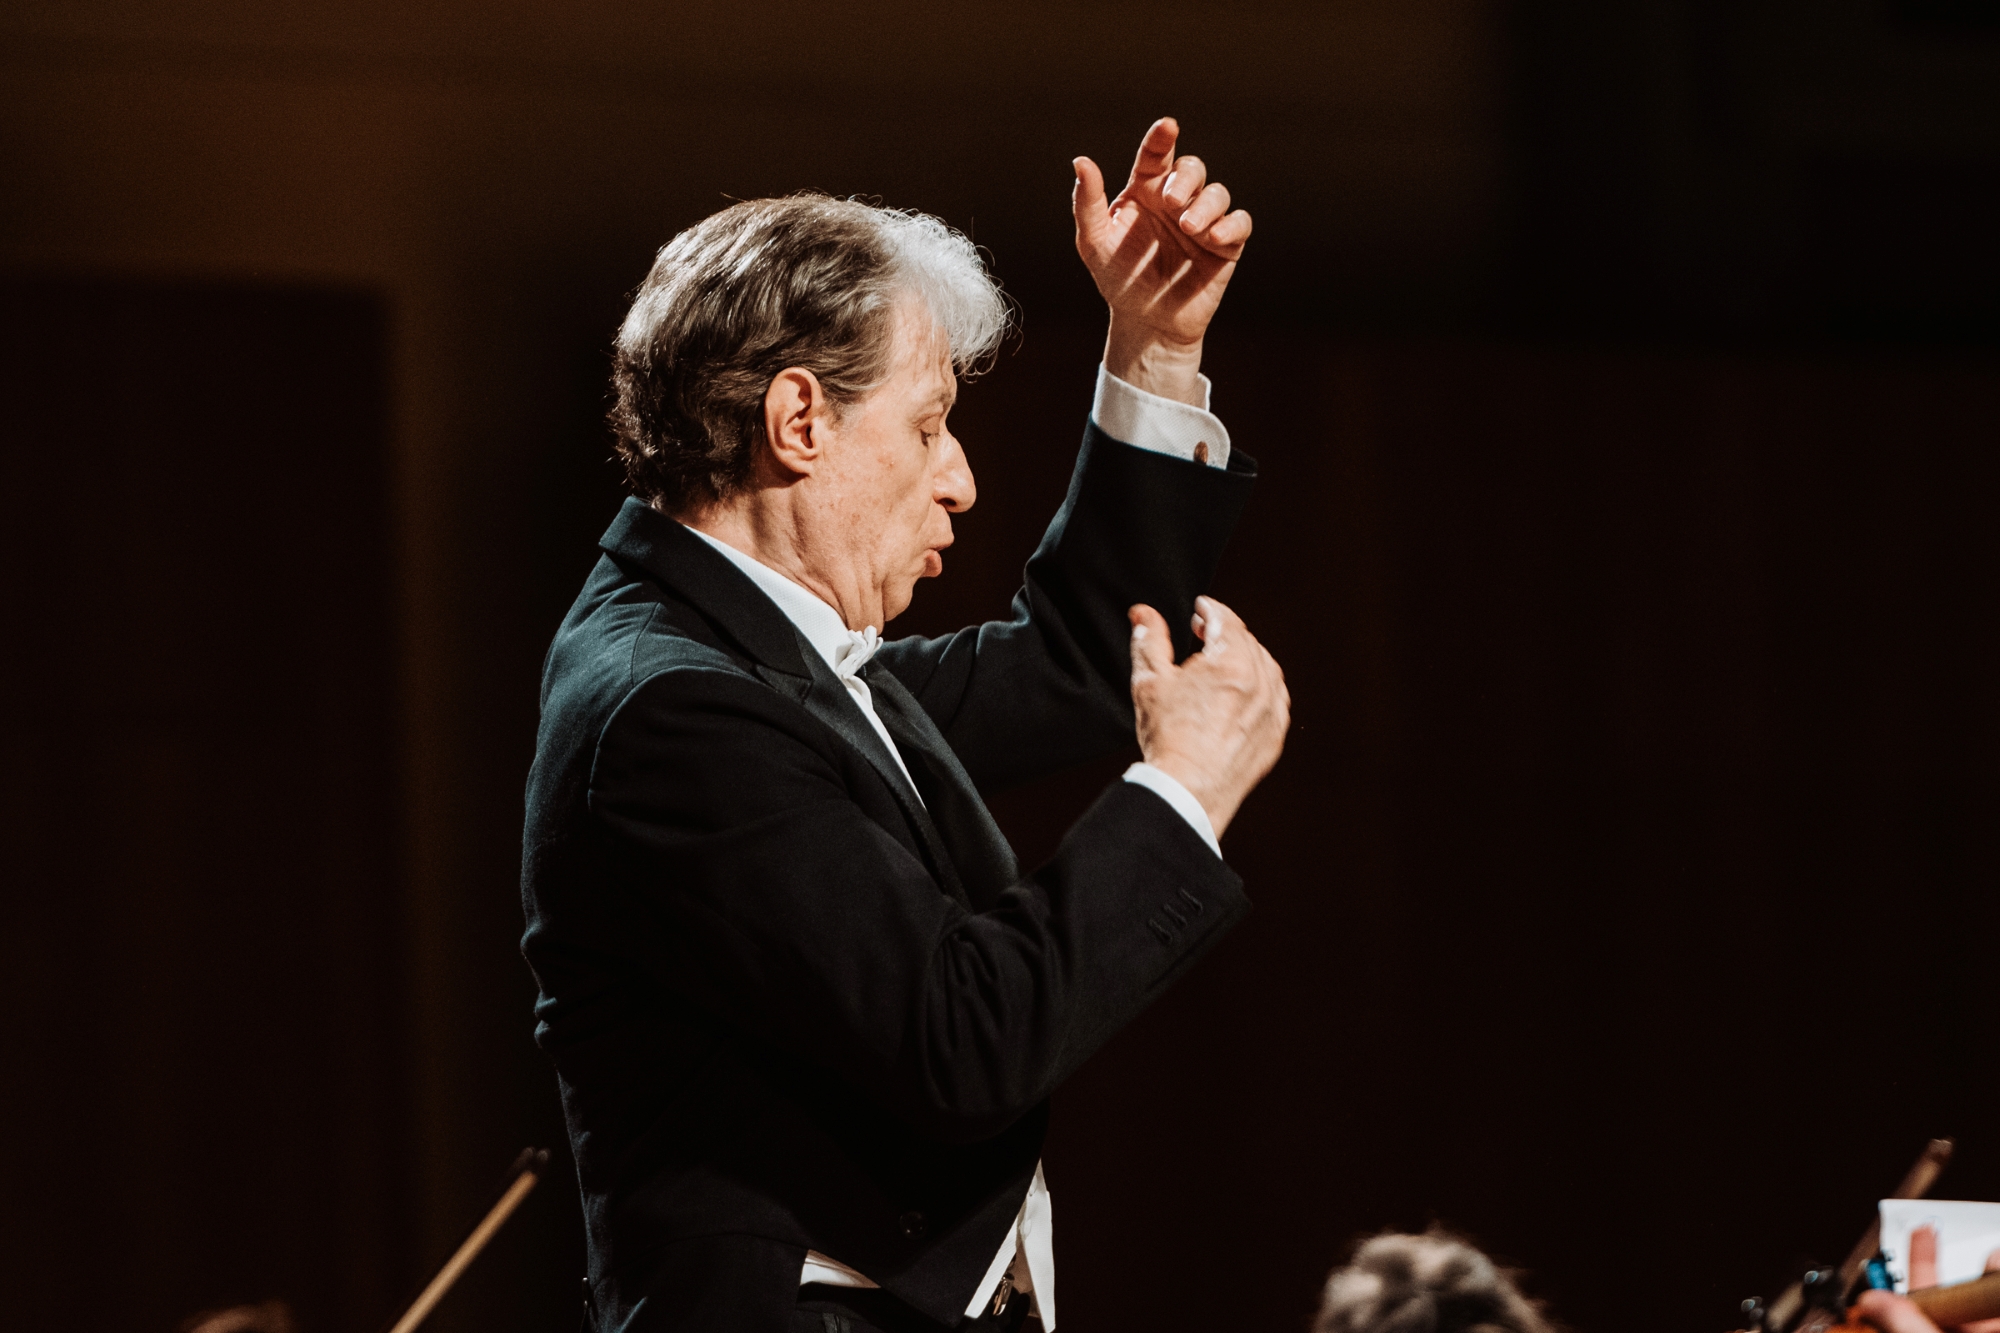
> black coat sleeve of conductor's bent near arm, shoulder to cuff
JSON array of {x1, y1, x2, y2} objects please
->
[{"x1": 590, "y1": 669, "x2": 1248, "y2": 1139}]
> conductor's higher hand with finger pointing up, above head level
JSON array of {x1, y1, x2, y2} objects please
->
[{"x1": 1070, "y1": 116, "x2": 1250, "y2": 402}]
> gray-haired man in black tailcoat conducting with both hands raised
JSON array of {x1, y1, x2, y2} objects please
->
[{"x1": 522, "y1": 120, "x2": 1290, "y2": 1333}]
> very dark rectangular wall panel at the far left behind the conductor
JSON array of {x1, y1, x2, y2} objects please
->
[{"x1": 0, "y1": 278, "x2": 418, "y2": 1329}]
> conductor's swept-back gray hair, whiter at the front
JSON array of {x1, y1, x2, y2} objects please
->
[{"x1": 610, "y1": 194, "x2": 1010, "y2": 512}]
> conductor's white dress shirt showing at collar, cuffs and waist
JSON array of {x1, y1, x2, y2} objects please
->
[{"x1": 688, "y1": 366, "x2": 1230, "y2": 1333}]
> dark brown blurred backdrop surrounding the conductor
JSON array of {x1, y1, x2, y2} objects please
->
[{"x1": 0, "y1": 0, "x2": 2000, "y2": 1333}]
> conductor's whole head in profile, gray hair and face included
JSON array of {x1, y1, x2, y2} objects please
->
[{"x1": 612, "y1": 194, "x2": 1008, "y2": 628}]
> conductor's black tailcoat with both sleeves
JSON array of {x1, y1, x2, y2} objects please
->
[{"x1": 522, "y1": 426, "x2": 1254, "y2": 1333}]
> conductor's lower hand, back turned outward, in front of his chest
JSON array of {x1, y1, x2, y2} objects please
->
[{"x1": 1128, "y1": 596, "x2": 1292, "y2": 839}]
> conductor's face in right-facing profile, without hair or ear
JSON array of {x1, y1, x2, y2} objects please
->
[{"x1": 814, "y1": 306, "x2": 978, "y2": 620}]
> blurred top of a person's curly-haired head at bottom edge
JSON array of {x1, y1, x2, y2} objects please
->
[{"x1": 1312, "y1": 1229, "x2": 1552, "y2": 1333}]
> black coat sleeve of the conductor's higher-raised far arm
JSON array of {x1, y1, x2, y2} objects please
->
[{"x1": 880, "y1": 424, "x2": 1256, "y2": 791}]
